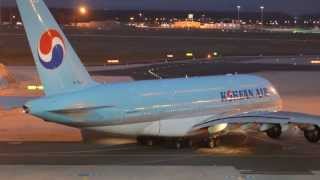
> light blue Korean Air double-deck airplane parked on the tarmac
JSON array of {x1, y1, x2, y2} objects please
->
[{"x1": 4, "y1": 0, "x2": 320, "y2": 149}]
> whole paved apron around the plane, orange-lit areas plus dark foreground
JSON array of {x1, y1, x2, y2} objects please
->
[{"x1": 0, "y1": 61, "x2": 320, "y2": 180}]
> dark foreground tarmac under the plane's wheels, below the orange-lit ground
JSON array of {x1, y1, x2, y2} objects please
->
[{"x1": 0, "y1": 132, "x2": 320, "y2": 180}]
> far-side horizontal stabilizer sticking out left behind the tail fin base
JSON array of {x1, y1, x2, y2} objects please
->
[{"x1": 0, "y1": 96, "x2": 39, "y2": 110}]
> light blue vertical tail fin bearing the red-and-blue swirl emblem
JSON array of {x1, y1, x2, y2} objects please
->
[{"x1": 17, "y1": 0, "x2": 96, "y2": 96}]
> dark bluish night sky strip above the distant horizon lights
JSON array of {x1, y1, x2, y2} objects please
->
[{"x1": 2, "y1": 0, "x2": 320, "y2": 15}]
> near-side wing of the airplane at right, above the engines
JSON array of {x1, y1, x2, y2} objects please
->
[{"x1": 193, "y1": 112, "x2": 320, "y2": 130}]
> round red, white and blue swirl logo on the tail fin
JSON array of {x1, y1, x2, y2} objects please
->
[{"x1": 38, "y1": 29, "x2": 65, "y2": 70}]
